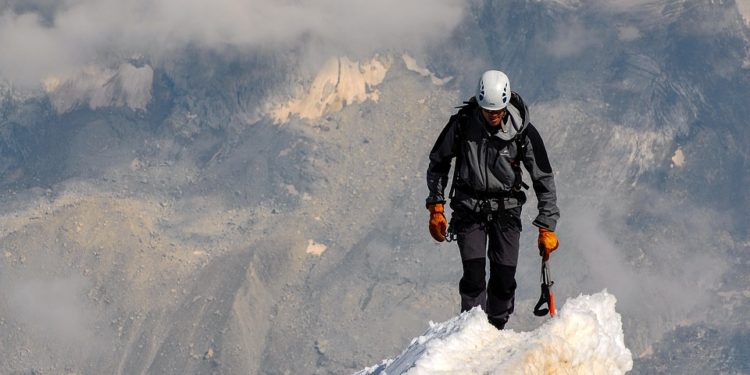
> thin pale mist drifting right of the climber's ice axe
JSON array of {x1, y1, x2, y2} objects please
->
[{"x1": 557, "y1": 197, "x2": 731, "y2": 352}]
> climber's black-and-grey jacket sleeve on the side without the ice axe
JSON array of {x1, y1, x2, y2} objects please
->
[{"x1": 426, "y1": 115, "x2": 459, "y2": 205}]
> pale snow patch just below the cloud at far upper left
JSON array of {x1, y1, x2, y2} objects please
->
[{"x1": 42, "y1": 63, "x2": 154, "y2": 114}]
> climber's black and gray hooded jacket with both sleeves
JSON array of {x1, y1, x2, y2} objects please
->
[{"x1": 427, "y1": 92, "x2": 560, "y2": 231}]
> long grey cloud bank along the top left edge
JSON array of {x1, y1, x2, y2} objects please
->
[{"x1": 0, "y1": 0, "x2": 464, "y2": 88}]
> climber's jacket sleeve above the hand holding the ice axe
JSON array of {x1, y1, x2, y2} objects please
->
[{"x1": 523, "y1": 124, "x2": 560, "y2": 231}]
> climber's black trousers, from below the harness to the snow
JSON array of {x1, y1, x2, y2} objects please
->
[{"x1": 451, "y1": 207, "x2": 521, "y2": 329}]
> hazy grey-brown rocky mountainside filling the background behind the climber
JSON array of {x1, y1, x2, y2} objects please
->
[{"x1": 0, "y1": 0, "x2": 750, "y2": 374}]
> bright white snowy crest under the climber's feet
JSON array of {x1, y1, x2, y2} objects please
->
[{"x1": 356, "y1": 291, "x2": 633, "y2": 375}]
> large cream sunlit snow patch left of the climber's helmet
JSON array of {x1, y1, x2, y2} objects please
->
[{"x1": 270, "y1": 56, "x2": 391, "y2": 124}]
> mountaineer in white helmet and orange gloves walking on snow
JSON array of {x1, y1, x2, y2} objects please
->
[{"x1": 427, "y1": 70, "x2": 560, "y2": 329}]
